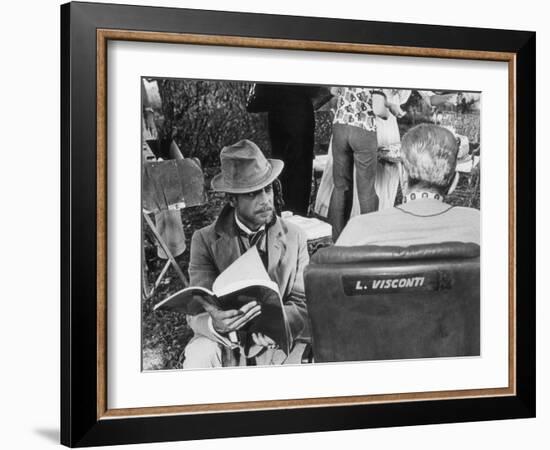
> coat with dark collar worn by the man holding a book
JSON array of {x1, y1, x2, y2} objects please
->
[{"x1": 187, "y1": 205, "x2": 310, "y2": 343}]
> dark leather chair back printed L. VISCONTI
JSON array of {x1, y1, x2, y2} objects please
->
[{"x1": 305, "y1": 242, "x2": 480, "y2": 362}]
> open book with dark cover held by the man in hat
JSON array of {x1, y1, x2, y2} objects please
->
[{"x1": 154, "y1": 247, "x2": 291, "y2": 355}]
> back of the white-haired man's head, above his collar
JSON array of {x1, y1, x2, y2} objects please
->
[{"x1": 401, "y1": 124, "x2": 458, "y2": 192}]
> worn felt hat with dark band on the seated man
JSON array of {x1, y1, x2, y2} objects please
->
[{"x1": 211, "y1": 139, "x2": 284, "y2": 194}]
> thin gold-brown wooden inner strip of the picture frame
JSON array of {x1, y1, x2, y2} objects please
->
[{"x1": 97, "y1": 29, "x2": 517, "y2": 420}]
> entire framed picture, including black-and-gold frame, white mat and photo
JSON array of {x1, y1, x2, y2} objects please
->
[{"x1": 52, "y1": 2, "x2": 540, "y2": 448}]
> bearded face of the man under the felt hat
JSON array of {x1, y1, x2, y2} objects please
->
[{"x1": 231, "y1": 184, "x2": 275, "y2": 230}]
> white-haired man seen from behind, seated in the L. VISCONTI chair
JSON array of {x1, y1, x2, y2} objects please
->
[{"x1": 336, "y1": 124, "x2": 480, "y2": 246}]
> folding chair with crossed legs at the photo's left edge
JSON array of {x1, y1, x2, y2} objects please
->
[{"x1": 142, "y1": 159, "x2": 204, "y2": 298}]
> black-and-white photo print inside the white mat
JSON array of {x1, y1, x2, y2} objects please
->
[{"x1": 142, "y1": 76, "x2": 483, "y2": 371}]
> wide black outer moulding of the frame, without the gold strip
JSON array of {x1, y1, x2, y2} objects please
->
[{"x1": 61, "y1": 3, "x2": 535, "y2": 447}]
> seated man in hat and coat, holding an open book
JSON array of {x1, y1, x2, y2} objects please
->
[{"x1": 184, "y1": 140, "x2": 309, "y2": 368}]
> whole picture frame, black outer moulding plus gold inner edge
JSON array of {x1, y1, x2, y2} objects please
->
[{"x1": 61, "y1": 2, "x2": 536, "y2": 447}]
